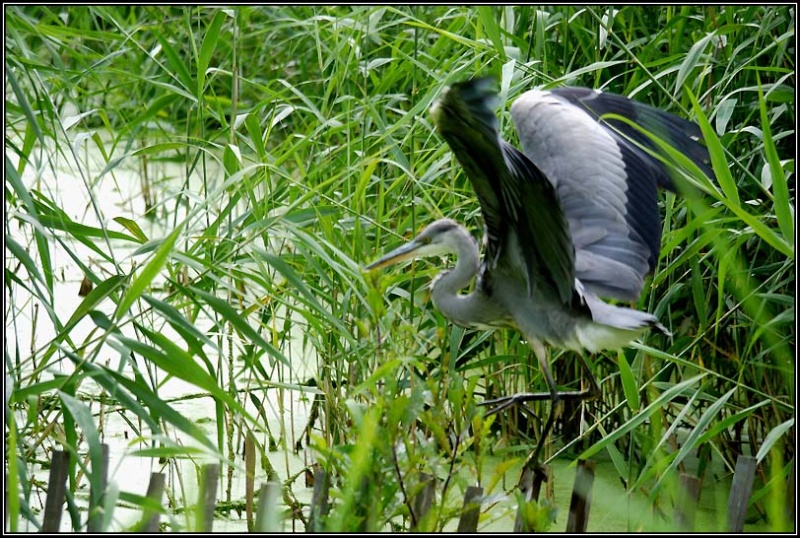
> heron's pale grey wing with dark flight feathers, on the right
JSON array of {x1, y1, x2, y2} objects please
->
[{"x1": 511, "y1": 88, "x2": 711, "y2": 300}]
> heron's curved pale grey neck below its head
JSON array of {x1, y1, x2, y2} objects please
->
[{"x1": 431, "y1": 227, "x2": 480, "y2": 323}]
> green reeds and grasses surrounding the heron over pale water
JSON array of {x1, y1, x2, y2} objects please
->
[{"x1": 5, "y1": 5, "x2": 796, "y2": 530}]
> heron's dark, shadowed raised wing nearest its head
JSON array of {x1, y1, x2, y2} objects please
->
[{"x1": 432, "y1": 78, "x2": 575, "y2": 304}]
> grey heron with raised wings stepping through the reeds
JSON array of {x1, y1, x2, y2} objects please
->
[{"x1": 366, "y1": 78, "x2": 713, "y2": 461}]
